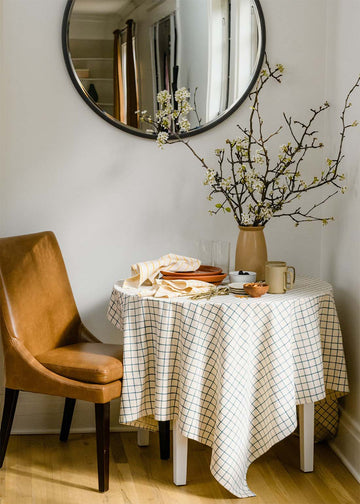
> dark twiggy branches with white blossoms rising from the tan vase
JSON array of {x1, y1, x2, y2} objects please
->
[{"x1": 136, "y1": 58, "x2": 360, "y2": 226}]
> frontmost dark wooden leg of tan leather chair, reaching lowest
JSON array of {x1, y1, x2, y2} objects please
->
[{"x1": 95, "y1": 402, "x2": 110, "y2": 492}]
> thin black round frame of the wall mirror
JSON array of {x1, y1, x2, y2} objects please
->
[{"x1": 61, "y1": 0, "x2": 266, "y2": 140}]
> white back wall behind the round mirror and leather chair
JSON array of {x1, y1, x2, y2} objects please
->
[{"x1": 0, "y1": 0, "x2": 347, "y2": 438}]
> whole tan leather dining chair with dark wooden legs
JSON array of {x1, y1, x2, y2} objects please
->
[{"x1": 0, "y1": 232, "x2": 123, "y2": 492}]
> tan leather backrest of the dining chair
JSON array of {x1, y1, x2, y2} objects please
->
[{"x1": 0, "y1": 231, "x2": 80, "y2": 355}]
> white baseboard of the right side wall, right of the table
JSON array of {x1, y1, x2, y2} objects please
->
[{"x1": 329, "y1": 408, "x2": 360, "y2": 483}]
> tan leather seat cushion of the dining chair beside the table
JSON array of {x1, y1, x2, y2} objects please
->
[{"x1": 36, "y1": 343, "x2": 123, "y2": 384}]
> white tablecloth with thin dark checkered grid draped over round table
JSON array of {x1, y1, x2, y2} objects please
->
[{"x1": 108, "y1": 278, "x2": 348, "y2": 497}]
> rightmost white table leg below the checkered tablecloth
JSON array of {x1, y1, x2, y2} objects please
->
[{"x1": 299, "y1": 403, "x2": 314, "y2": 472}]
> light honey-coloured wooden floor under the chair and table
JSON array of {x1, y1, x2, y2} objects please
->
[{"x1": 0, "y1": 432, "x2": 360, "y2": 504}]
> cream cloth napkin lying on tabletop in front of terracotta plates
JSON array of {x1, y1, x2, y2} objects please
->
[{"x1": 133, "y1": 279, "x2": 212, "y2": 298}]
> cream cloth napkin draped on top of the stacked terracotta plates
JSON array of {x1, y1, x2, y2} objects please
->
[{"x1": 123, "y1": 254, "x2": 201, "y2": 287}]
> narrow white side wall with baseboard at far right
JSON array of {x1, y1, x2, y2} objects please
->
[{"x1": 321, "y1": 0, "x2": 360, "y2": 480}]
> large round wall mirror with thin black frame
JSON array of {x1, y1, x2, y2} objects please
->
[{"x1": 62, "y1": 0, "x2": 265, "y2": 138}]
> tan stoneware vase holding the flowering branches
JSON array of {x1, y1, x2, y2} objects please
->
[{"x1": 235, "y1": 226, "x2": 267, "y2": 281}]
